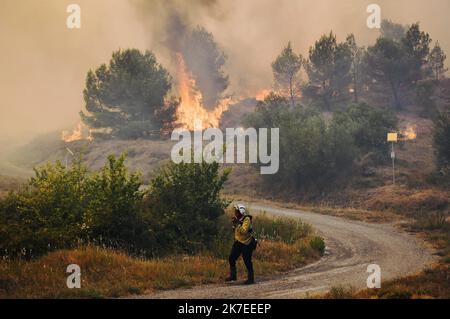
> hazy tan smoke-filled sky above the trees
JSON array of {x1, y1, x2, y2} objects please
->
[{"x1": 0, "y1": 0, "x2": 450, "y2": 140}]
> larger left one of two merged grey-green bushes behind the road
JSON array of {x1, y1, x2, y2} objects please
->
[{"x1": 246, "y1": 94, "x2": 356, "y2": 187}]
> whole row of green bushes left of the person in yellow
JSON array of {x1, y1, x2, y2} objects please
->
[{"x1": 0, "y1": 155, "x2": 229, "y2": 258}]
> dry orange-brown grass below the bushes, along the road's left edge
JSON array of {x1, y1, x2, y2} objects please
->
[{"x1": 0, "y1": 239, "x2": 319, "y2": 298}]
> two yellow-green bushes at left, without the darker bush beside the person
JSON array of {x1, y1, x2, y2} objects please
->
[{"x1": 0, "y1": 156, "x2": 145, "y2": 258}]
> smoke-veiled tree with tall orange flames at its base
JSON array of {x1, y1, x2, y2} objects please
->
[{"x1": 171, "y1": 25, "x2": 231, "y2": 130}]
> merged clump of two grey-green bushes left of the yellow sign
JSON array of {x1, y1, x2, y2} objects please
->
[{"x1": 245, "y1": 94, "x2": 398, "y2": 190}]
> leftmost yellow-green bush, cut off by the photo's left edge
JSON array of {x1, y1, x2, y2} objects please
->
[{"x1": 0, "y1": 163, "x2": 87, "y2": 257}]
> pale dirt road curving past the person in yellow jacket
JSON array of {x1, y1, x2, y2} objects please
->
[{"x1": 139, "y1": 204, "x2": 434, "y2": 299}]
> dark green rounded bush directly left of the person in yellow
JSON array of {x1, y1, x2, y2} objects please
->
[{"x1": 145, "y1": 162, "x2": 230, "y2": 253}]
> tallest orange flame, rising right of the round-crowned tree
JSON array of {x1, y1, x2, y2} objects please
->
[{"x1": 177, "y1": 53, "x2": 231, "y2": 130}]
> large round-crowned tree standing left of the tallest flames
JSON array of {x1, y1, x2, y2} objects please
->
[{"x1": 80, "y1": 49, "x2": 177, "y2": 138}]
